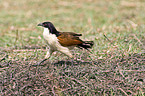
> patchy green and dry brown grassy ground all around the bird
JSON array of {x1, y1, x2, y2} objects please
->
[{"x1": 0, "y1": 0, "x2": 145, "y2": 96}]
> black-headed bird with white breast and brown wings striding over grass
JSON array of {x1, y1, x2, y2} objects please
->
[{"x1": 37, "y1": 21, "x2": 94, "y2": 59}]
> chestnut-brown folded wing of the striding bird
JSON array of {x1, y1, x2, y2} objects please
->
[{"x1": 57, "y1": 32, "x2": 83, "y2": 47}]
